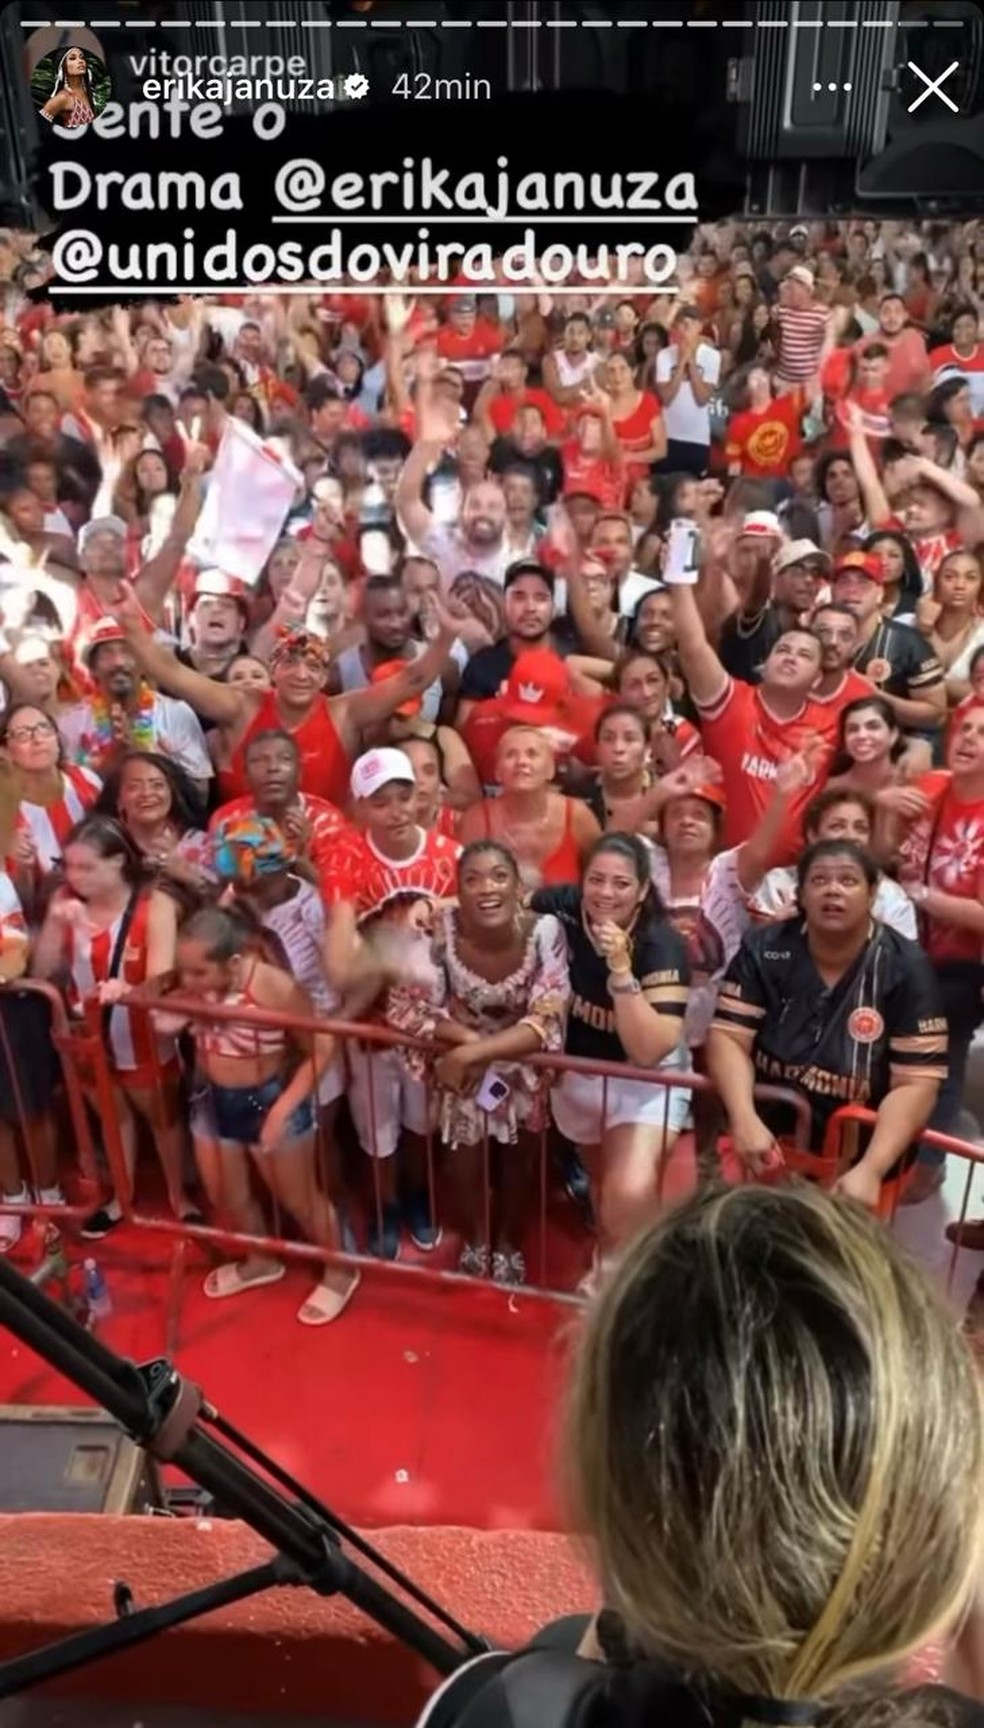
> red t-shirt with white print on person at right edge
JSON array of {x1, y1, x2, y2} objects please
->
[{"x1": 899, "y1": 769, "x2": 984, "y2": 964}]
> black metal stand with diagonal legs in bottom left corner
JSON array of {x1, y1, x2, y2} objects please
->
[{"x1": 0, "y1": 1258, "x2": 491, "y2": 1699}]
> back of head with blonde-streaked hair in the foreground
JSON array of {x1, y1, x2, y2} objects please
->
[{"x1": 567, "y1": 1185, "x2": 984, "y2": 1709}]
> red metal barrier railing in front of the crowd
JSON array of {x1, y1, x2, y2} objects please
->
[{"x1": 0, "y1": 983, "x2": 984, "y2": 1348}]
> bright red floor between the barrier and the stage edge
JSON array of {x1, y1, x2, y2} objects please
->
[{"x1": 0, "y1": 1201, "x2": 590, "y2": 1529}]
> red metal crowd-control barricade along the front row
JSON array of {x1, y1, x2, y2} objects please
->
[{"x1": 0, "y1": 983, "x2": 984, "y2": 1332}]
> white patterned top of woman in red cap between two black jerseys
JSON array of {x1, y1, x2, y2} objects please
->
[{"x1": 650, "y1": 847, "x2": 751, "y2": 1051}]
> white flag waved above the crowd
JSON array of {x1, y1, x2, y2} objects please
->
[{"x1": 188, "y1": 418, "x2": 304, "y2": 586}]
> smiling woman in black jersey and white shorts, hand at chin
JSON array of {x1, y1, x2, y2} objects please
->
[{"x1": 531, "y1": 833, "x2": 690, "y2": 1293}]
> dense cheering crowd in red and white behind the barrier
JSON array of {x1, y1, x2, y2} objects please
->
[{"x1": 0, "y1": 221, "x2": 984, "y2": 1325}]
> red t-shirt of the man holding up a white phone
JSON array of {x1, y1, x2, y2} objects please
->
[{"x1": 700, "y1": 677, "x2": 832, "y2": 864}]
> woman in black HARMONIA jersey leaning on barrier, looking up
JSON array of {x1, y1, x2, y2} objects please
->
[{"x1": 707, "y1": 840, "x2": 946, "y2": 1206}]
